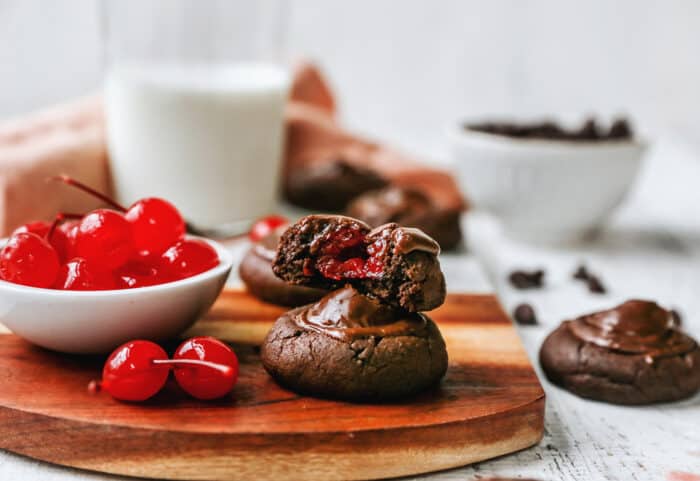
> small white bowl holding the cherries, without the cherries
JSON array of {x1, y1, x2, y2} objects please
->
[{"x1": 0, "y1": 239, "x2": 233, "y2": 354}]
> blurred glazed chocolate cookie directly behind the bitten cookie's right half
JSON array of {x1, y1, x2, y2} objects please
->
[{"x1": 346, "y1": 186, "x2": 462, "y2": 250}]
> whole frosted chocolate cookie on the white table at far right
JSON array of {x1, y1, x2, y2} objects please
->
[{"x1": 540, "y1": 300, "x2": 700, "y2": 404}]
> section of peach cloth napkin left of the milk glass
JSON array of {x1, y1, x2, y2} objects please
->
[{"x1": 0, "y1": 96, "x2": 110, "y2": 236}]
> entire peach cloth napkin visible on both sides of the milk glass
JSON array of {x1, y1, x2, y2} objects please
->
[{"x1": 0, "y1": 63, "x2": 465, "y2": 235}]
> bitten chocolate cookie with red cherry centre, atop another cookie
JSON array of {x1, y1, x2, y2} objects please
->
[{"x1": 272, "y1": 215, "x2": 445, "y2": 312}]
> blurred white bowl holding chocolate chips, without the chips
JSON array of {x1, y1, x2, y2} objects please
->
[{"x1": 449, "y1": 124, "x2": 646, "y2": 243}]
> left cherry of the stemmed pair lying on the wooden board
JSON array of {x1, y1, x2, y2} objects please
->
[{"x1": 100, "y1": 341, "x2": 170, "y2": 401}]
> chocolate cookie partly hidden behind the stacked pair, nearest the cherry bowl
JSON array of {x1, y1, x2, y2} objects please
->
[{"x1": 238, "y1": 227, "x2": 328, "y2": 307}]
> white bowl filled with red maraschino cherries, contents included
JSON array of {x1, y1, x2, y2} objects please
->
[{"x1": 0, "y1": 176, "x2": 233, "y2": 353}]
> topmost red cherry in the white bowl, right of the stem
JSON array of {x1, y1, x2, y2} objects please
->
[{"x1": 124, "y1": 197, "x2": 185, "y2": 255}]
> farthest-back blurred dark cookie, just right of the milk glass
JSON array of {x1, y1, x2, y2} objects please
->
[{"x1": 285, "y1": 159, "x2": 394, "y2": 212}]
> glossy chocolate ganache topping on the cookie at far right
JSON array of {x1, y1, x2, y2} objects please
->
[{"x1": 567, "y1": 300, "x2": 697, "y2": 359}]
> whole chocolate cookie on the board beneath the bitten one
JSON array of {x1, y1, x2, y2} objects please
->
[{"x1": 261, "y1": 286, "x2": 447, "y2": 401}]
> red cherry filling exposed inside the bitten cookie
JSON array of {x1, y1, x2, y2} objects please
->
[{"x1": 304, "y1": 225, "x2": 389, "y2": 280}]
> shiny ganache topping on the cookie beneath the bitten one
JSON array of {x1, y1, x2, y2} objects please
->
[{"x1": 292, "y1": 286, "x2": 426, "y2": 341}]
